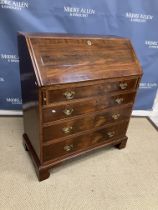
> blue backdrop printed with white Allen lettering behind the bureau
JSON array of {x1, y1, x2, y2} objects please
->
[{"x1": 0, "y1": 0, "x2": 158, "y2": 114}]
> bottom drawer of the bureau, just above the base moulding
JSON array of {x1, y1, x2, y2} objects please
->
[{"x1": 43, "y1": 122, "x2": 128, "y2": 162}]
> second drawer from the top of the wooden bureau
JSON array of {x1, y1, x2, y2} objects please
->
[{"x1": 43, "y1": 92, "x2": 135, "y2": 123}]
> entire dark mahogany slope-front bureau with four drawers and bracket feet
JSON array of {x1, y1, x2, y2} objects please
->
[{"x1": 18, "y1": 33, "x2": 142, "y2": 181}]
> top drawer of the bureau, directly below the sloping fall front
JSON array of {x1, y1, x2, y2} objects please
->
[{"x1": 47, "y1": 79, "x2": 137, "y2": 104}]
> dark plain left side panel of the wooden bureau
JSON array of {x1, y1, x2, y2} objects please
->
[{"x1": 18, "y1": 35, "x2": 40, "y2": 159}]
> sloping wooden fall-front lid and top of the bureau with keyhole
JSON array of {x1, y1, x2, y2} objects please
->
[{"x1": 19, "y1": 33, "x2": 142, "y2": 86}]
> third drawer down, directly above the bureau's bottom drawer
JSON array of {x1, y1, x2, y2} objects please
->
[{"x1": 43, "y1": 105, "x2": 132, "y2": 142}]
